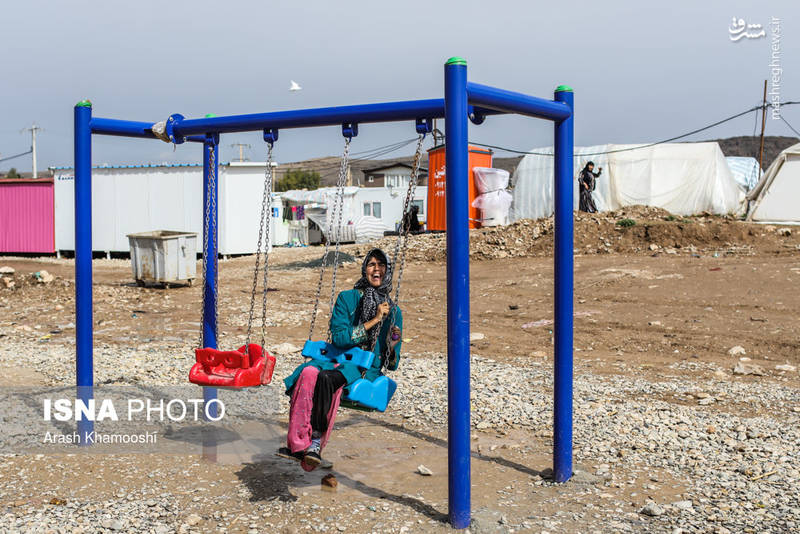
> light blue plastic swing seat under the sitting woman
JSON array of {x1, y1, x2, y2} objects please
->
[{"x1": 302, "y1": 340, "x2": 397, "y2": 412}]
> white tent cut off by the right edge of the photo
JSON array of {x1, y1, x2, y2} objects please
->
[{"x1": 747, "y1": 143, "x2": 800, "y2": 222}]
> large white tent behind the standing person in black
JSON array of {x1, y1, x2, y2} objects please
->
[{"x1": 512, "y1": 143, "x2": 745, "y2": 220}]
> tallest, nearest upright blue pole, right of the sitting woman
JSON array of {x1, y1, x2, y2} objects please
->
[{"x1": 444, "y1": 57, "x2": 471, "y2": 528}]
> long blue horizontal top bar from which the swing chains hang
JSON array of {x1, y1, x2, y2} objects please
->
[{"x1": 173, "y1": 98, "x2": 444, "y2": 136}]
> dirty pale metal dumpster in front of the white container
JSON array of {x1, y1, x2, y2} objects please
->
[{"x1": 128, "y1": 230, "x2": 197, "y2": 287}]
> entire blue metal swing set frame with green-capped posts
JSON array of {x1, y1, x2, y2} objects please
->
[{"x1": 75, "y1": 57, "x2": 574, "y2": 529}]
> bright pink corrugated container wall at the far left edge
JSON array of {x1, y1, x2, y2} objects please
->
[{"x1": 0, "y1": 179, "x2": 55, "y2": 253}]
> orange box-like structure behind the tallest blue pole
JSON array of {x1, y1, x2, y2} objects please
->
[{"x1": 426, "y1": 145, "x2": 492, "y2": 230}]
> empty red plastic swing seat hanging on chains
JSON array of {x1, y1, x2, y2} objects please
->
[{"x1": 189, "y1": 343, "x2": 275, "y2": 388}]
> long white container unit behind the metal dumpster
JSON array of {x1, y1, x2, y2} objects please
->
[{"x1": 53, "y1": 162, "x2": 288, "y2": 255}]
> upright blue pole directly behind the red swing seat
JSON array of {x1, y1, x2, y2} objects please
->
[{"x1": 203, "y1": 135, "x2": 219, "y2": 417}]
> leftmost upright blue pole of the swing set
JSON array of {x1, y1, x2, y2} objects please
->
[{"x1": 75, "y1": 100, "x2": 94, "y2": 445}]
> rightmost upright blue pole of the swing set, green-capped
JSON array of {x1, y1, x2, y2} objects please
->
[{"x1": 553, "y1": 85, "x2": 574, "y2": 482}]
